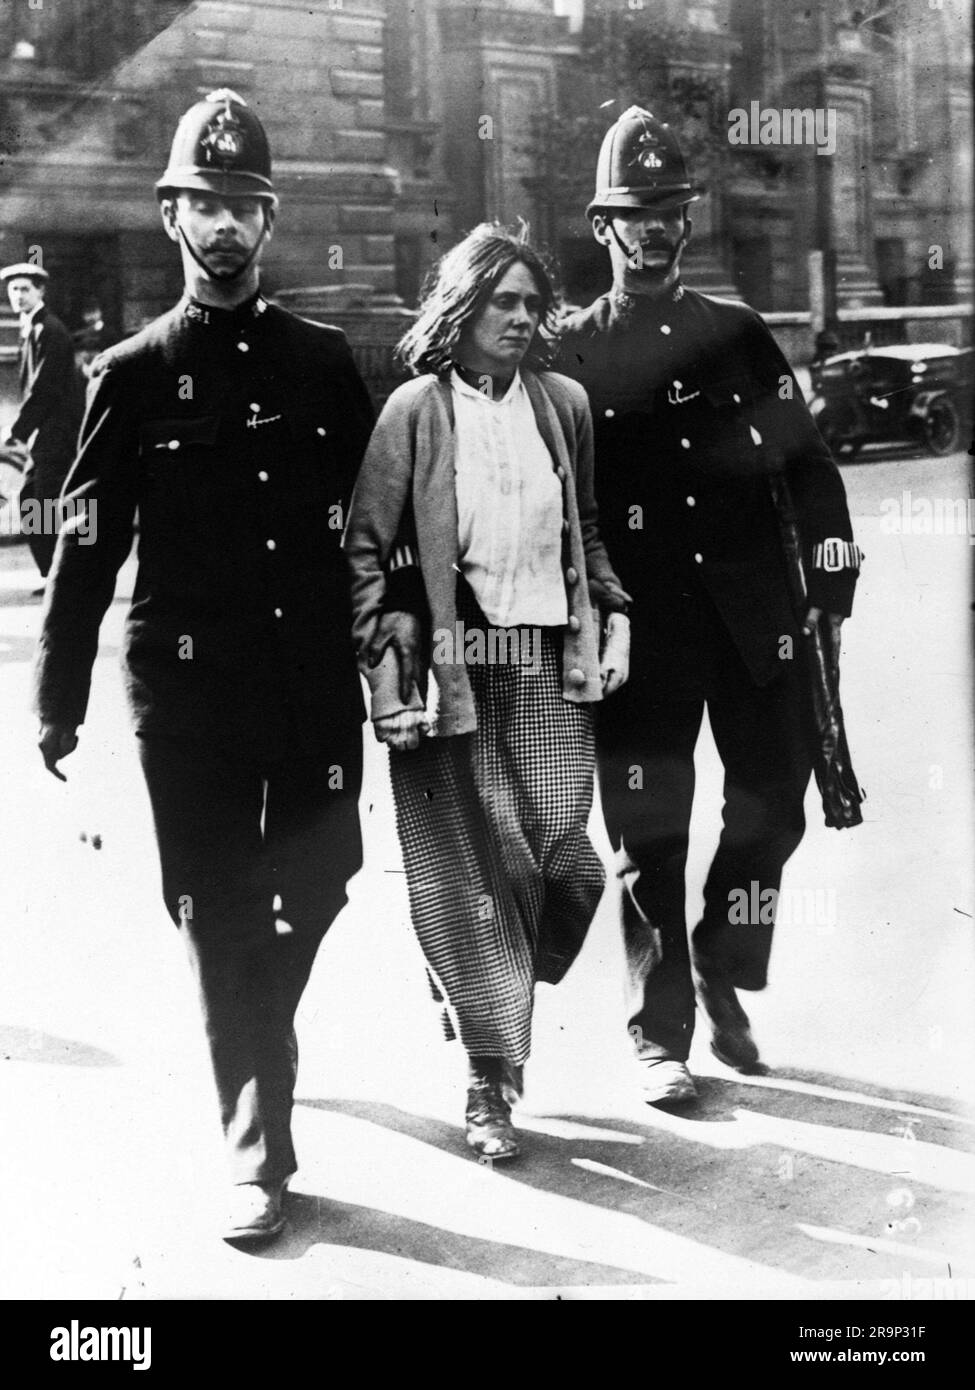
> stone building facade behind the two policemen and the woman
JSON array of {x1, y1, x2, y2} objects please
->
[{"x1": 0, "y1": 0, "x2": 972, "y2": 405}]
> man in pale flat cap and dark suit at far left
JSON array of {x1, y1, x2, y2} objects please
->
[{"x1": 0, "y1": 261, "x2": 83, "y2": 594}]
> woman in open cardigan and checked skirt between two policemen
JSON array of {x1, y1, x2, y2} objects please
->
[{"x1": 345, "y1": 224, "x2": 629, "y2": 1159}]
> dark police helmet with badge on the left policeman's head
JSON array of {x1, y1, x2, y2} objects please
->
[{"x1": 156, "y1": 88, "x2": 275, "y2": 202}]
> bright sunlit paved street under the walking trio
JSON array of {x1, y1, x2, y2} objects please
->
[{"x1": 0, "y1": 450, "x2": 975, "y2": 1300}]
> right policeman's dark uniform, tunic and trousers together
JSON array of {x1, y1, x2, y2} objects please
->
[{"x1": 558, "y1": 285, "x2": 857, "y2": 1061}]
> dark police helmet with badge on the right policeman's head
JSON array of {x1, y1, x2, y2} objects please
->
[{"x1": 586, "y1": 106, "x2": 704, "y2": 218}]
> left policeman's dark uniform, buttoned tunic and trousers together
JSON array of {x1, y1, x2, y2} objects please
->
[{"x1": 36, "y1": 296, "x2": 373, "y2": 1183}]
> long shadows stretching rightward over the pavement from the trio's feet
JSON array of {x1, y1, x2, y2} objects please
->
[{"x1": 248, "y1": 1072, "x2": 975, "y2": 1297}]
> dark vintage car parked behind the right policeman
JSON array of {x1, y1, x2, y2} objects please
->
[{"x1": 809, "y1": 343, "x2": 972, "y2": 459}]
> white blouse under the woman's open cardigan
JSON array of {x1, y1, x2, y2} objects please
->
[{"x1": 451, "y1": 370, "x2": 569, "y2": 627}]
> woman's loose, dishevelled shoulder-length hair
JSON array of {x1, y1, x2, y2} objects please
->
[{"x1": 396, "y1": 222, "x2": 555, "y2": 377}]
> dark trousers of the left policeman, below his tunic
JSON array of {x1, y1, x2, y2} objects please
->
[{"x1": 139, "y1": 730, "x2": 362, "y2": 1183}]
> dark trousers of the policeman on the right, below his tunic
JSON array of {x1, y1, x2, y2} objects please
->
[{"x1": 597, "y1": 645, "x2": 811, "y2": 1062}]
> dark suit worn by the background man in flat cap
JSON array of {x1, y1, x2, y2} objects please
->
[{"x1": 10, "y1": 304, "x2": 83, "y2": 578}]
